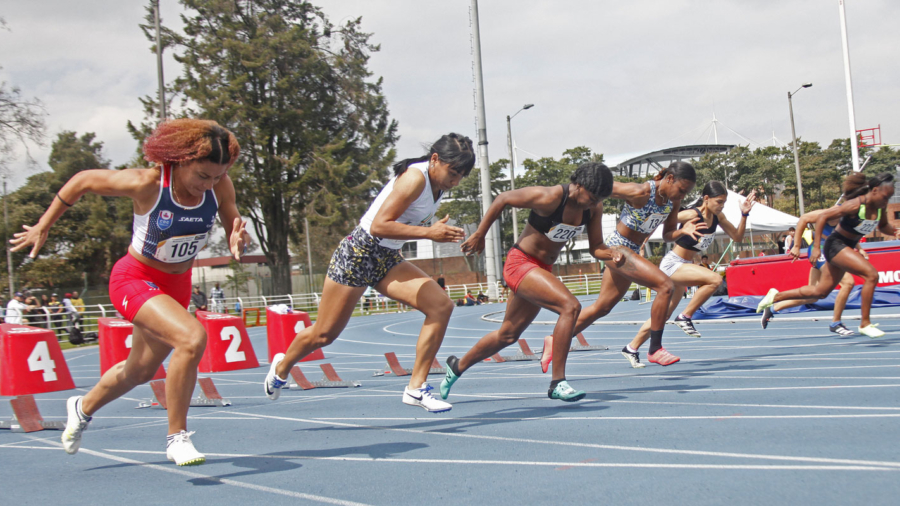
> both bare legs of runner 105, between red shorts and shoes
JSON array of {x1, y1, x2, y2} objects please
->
[{"x1": 81, "y1": 295, "x2": 206, "y2": 434}]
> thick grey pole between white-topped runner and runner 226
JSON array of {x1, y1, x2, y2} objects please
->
[{"x1": 471, "y1": 0, "x2": 499, "y2": 300}]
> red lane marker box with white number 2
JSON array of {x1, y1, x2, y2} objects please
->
[{"x1": 197, "y1": 311, "x2": 259, "y2": 372}]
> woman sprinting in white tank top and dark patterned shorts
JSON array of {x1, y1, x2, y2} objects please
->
[{"x1": 264, "y1": 133, "x2": 475, "y2": 413}]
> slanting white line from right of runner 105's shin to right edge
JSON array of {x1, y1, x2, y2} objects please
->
[{"x1": 221, "y1": 411, "x2": 900, "y2": 468}]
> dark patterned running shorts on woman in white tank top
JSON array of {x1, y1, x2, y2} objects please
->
[{"x1": 328, "y1": 227, "x2": 403, "y2": 287}]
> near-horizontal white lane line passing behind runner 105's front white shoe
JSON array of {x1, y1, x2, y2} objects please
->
[{"x1": 58, "y1": 446, "x2": 884, "y2": 472}]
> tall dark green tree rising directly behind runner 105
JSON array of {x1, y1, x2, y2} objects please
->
[{"x1": 149, "y1": 0, "x2": 397, "y2": 293}]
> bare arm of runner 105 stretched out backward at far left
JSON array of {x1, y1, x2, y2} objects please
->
[{"x1": 9, "y1": 169, "x2": 159, "y2": 258}]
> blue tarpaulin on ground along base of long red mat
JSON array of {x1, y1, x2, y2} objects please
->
[{"x1": 693, "y1": 286, "x2": 900, "y2": 320}]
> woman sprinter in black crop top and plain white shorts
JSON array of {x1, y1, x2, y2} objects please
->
[{"x1": 622, "y1": 181, "x2": 756, "y2": 368}]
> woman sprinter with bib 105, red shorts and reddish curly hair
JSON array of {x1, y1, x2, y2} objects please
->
[{"x1": 11, "y1": 119, "x2": 250, "y2": 466}]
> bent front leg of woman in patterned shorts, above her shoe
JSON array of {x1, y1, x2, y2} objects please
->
[{"x1": 375, "y1": 262, "x2": 453, "y2": 389}]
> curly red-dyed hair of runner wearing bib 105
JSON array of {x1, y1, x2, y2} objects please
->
[{"x1": 144, "y1": 118, "x2": 241, "y2": 165}]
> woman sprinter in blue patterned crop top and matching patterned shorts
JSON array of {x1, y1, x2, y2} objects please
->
[{"x1": 574, "y1": 162, "x2": 701, "y2": 365}]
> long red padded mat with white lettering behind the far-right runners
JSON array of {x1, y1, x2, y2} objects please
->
[{"x1": 726, "y1": 241, "x2": 900, "y2": 297}]
